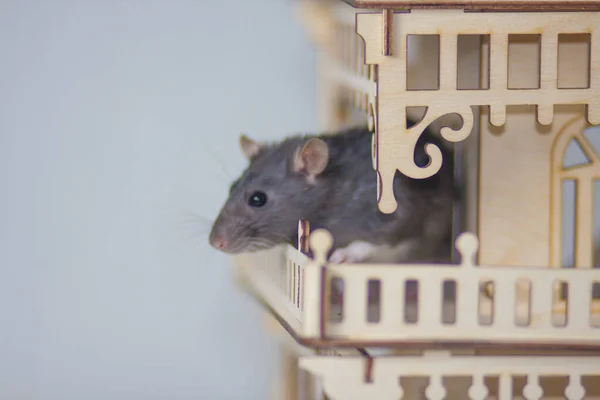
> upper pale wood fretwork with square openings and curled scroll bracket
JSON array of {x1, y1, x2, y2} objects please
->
[{"x1": 356, "y1": 10, "x2": 600, "y2": 214}]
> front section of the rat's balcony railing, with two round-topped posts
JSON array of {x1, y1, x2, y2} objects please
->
[{"x1": 302, "y1": 230, "x2": 600, "y2": 350}]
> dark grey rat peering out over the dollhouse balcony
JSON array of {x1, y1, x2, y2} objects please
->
[{"x1": 209, "y1": 120, "x2": 457, "y2": 263}]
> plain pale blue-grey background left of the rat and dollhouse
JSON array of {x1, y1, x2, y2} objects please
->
[{"x1": 0, "y1": 0, "x2": 316, "y2": 400}]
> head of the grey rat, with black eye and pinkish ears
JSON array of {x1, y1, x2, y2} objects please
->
[{"x1": 209, "y1": 135, "x2": 329, "y2": 254}]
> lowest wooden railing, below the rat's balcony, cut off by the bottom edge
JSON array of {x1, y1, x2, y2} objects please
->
[{"x1": 300, "y1": 352, "x2": 600, "y2": 400}]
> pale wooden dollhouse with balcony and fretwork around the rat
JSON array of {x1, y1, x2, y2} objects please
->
[{"x1": 236, "y1": 0, "x2": 600, "y2": 400}]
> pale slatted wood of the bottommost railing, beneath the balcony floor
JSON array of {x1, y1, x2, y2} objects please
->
[{"x1": 300, "y1": 351, "x2": 600, "y2": 400}]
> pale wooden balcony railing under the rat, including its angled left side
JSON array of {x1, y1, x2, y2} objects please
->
[{"x1": 245, "y1": 222, "x2": 600, "y2": 350}]
